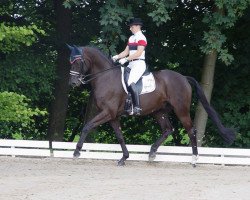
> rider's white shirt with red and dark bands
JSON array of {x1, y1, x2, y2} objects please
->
[{"x1": 128, "y1": 31, "x2": 147, "y2": 59}]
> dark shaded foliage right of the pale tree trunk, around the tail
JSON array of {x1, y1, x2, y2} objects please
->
[{"x1": 203, "y1": 7, "x2": 250, "y2": 148}]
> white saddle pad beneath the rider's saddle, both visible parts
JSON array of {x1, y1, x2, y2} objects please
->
[{"x1": 121, "y1": 67, "x2": 155, "y2": 95}]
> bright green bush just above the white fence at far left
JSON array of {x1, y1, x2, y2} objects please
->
[{"x1": 0, "y1": 92, "x2": 47, "y2": 139}]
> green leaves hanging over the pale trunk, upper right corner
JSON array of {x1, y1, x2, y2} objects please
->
[{"x1": 201, "y1": 0, "x2": 250, "y2": 65}]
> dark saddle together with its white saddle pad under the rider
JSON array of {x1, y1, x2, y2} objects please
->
[{"x1": 121, "y1": 67, "x2": 155, "y2": 114}]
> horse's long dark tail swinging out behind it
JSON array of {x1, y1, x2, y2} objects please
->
[{"x1": 186, "y1": 76, "x2": 235, "y2": 144}]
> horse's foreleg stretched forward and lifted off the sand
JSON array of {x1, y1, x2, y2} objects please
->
[{"x1": 73, "y1": 111, "x2": 111, "y2": 158}]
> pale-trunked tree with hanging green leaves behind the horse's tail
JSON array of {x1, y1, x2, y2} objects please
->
[{"x1": 194, "y1": 0, "x2": 249, "y2": 146}]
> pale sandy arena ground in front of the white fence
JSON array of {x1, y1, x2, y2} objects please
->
[{"x1": 0, "y1": 157, "x2": 250, "y2": 200}]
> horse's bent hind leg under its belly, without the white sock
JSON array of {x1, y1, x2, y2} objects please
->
[{"x1": 149, "y1": 111, "x2": 173, "y2": 161}]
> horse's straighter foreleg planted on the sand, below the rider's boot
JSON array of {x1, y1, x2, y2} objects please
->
[{"x1": 110, "y1": 119, "x2": 129, "y2": 166}]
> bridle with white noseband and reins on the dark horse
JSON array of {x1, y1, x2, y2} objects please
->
[{"x1": 70, "y1": 55, "x2": 121, "y2": 85}]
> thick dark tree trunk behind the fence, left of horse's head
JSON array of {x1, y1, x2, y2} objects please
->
[{"x1": 48, "y1": 0, "x2": 72, "y2": 141}]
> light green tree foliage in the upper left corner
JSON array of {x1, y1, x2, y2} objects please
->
[{"x1": 0, "y1": 0, "x2": 45, "y2": 53}]
